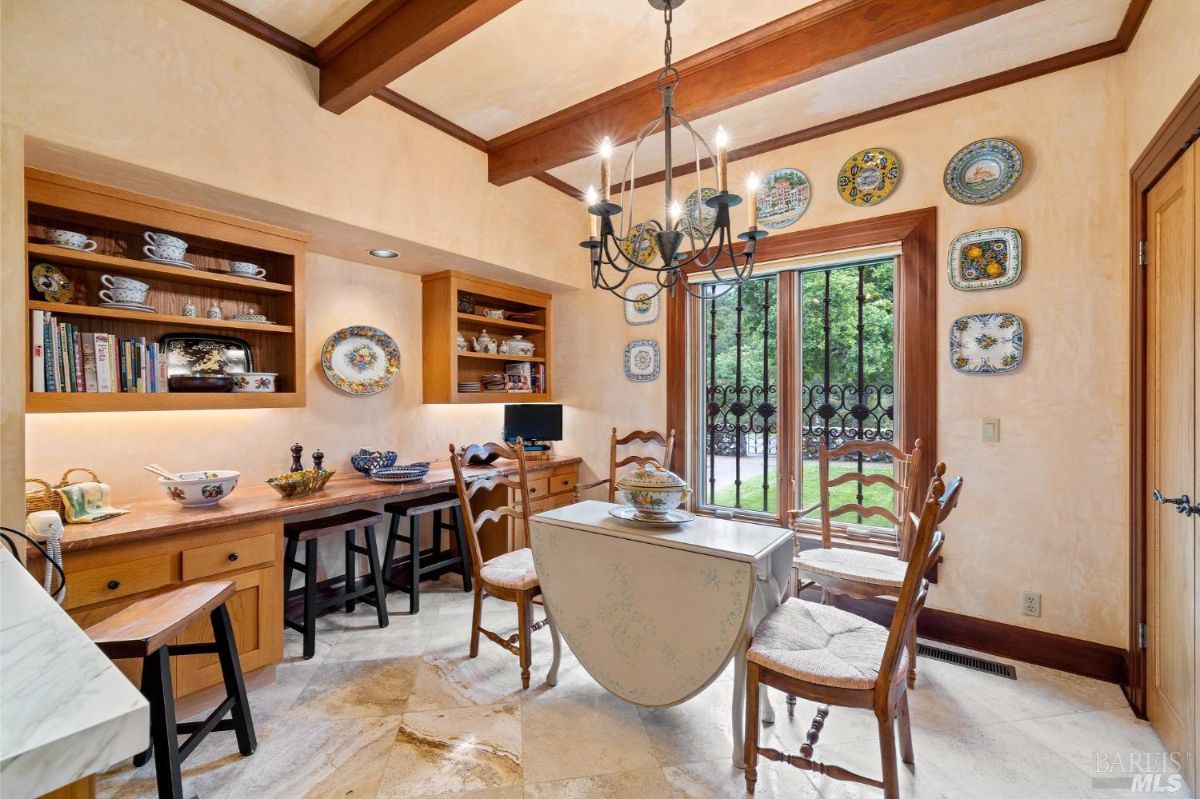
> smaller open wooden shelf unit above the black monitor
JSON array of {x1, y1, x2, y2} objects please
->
[{"x1": 421, "y1": 271, "x2": 553, "y2": 403}]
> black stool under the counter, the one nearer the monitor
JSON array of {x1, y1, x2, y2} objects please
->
[{"x1": 383, "y1": 494, "x2": 470, "y2": 613}]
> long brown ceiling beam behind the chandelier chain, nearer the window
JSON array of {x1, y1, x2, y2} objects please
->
[{"x1": 487, "y1": 0, "x2": 1039, "y2": 186}]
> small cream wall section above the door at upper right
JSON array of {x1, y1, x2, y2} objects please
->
[{"x1": 1122, "y1": 0, "x2": 1200, "y2": 166}]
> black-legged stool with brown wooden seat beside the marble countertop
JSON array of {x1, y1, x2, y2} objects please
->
[{"x1": 86, "y1": 579, "x2": 258, "y2": 799}]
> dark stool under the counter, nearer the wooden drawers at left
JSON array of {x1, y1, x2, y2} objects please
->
[{"x1": 283, "y1": 509, "x2": 388, "y2": 660}]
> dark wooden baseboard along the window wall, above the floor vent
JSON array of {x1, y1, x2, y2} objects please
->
[{"x1": 820, "y1": 596, "x2": 1128, "y2": 686}]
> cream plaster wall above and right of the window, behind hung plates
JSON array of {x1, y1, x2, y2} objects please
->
[{"x1": 624, "y1": 59, "x2": 1129, "y2": 647}]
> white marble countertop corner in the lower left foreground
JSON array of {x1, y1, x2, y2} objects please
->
[{"x1": 0, "y1": 547, "x2": 150, "y2": 799}]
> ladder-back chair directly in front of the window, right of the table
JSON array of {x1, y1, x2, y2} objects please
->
[{"x1": 791, "y1": 438, "x2": 936, "y2": 686}]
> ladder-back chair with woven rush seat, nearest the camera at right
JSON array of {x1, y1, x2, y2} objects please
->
[{"x1": 745, "y1": 463, "x2": 962, "y2": 799}]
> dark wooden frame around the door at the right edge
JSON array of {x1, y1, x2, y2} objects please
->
[{"x1": 1122, "y1": 78, "x2": 1200, "y2": 719}]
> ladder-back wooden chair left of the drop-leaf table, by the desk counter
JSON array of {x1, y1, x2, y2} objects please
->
[{"x1": 450, "y1": 439, "x2": 562, "y2": 689}]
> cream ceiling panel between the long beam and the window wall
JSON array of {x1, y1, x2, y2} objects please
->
[{"x1": 550, "y1": 0, "x2": 1128, "y2": 191}]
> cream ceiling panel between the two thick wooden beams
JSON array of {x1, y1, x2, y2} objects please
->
[{"x1": 390, "y1": 0, "x2": 817, "y2": 139}]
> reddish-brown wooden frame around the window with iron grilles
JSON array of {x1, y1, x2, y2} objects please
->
[{"x1": 666, "y1": 208, "x2": 942, "y2": 532}]
